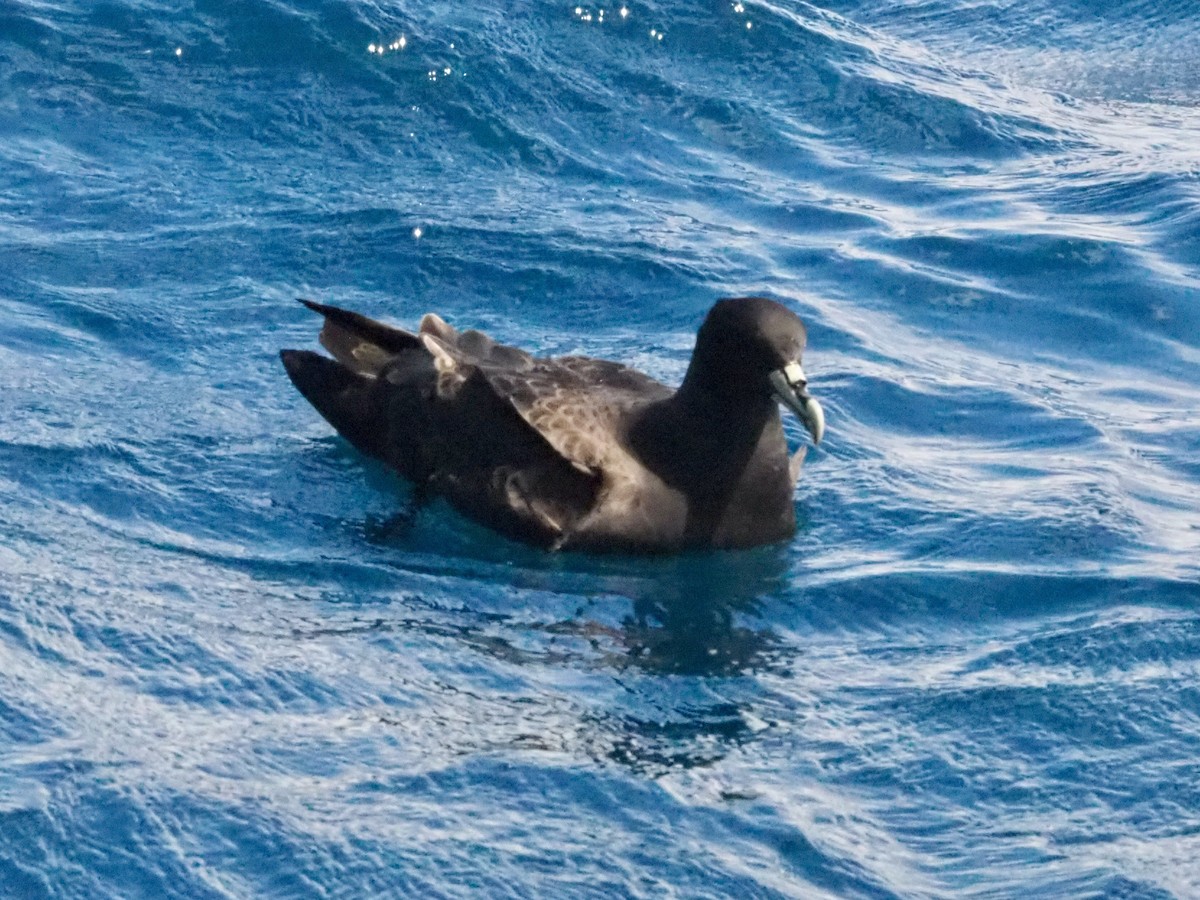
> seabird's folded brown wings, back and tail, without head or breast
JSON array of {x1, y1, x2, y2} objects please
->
[{"x1": 283, "y1": 301, "x2": 671, "y2": 545}]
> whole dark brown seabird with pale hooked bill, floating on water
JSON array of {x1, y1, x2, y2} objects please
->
[{"x1": 280, "y1": 298, "x2": 824, "y2": 553}]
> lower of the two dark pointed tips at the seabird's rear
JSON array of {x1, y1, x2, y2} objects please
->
[{"x1": 280, "y1": 350, "x2": 386, "y2": 458}]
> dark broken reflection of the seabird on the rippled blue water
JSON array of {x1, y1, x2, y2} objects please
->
[{"x1": 358, "y1": 504, "x2": 794, "y2": 777}]
